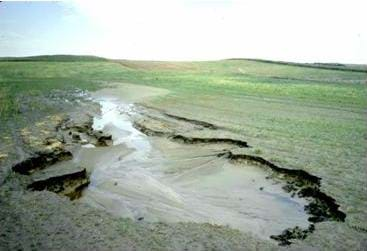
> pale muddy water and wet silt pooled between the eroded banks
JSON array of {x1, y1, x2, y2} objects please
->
[{"x1": 79, "y1": 98, "x2": 308, "y2": 239}]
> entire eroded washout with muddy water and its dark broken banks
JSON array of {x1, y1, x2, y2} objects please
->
[{"x1": 2, "y1": 90, "x2": 346, "y2": 245}]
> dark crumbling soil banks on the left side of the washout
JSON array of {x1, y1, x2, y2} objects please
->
[{"x1": 12, "y1": 101, "x2": 112, "y2": 200}]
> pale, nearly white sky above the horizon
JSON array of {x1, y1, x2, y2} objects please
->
[{"x1": 0, "y1": 0, "x2": 367, "y2": 64}]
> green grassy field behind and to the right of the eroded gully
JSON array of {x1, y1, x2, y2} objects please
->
[{"x1": 0, "y1": 56, "x2": 367, "y2": 248}]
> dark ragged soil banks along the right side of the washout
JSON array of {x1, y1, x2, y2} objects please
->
[{"x1": 134, "y1": 102, "x2": 346, "y2": 245}]
